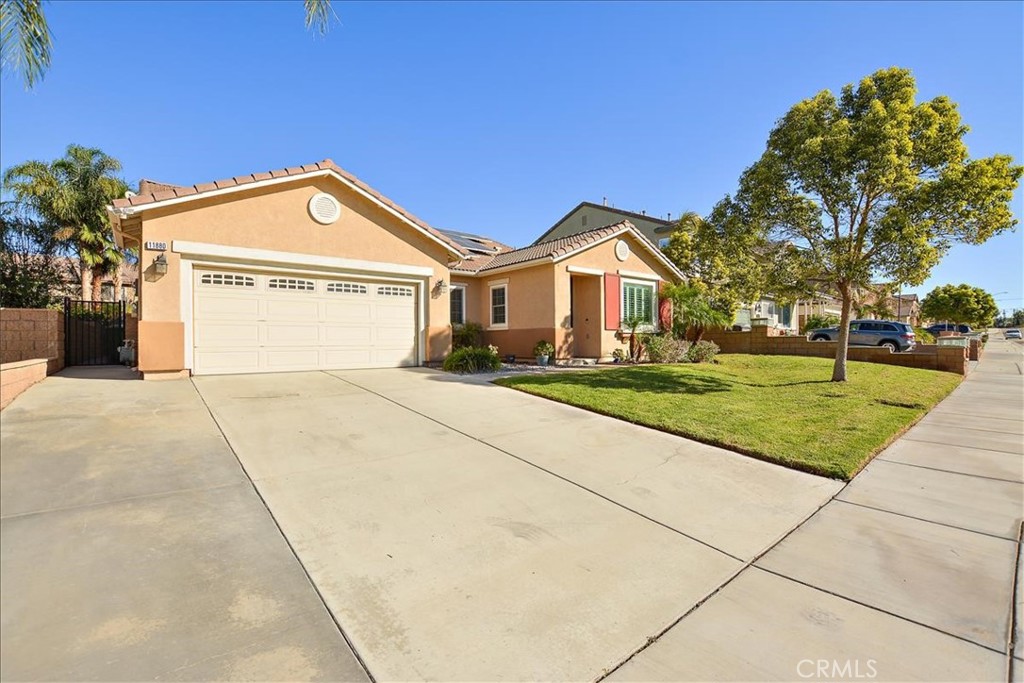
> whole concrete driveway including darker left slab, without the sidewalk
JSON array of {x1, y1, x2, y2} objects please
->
[{"x1": 0, "y1": 370, "x2": 840, "y2": 680}]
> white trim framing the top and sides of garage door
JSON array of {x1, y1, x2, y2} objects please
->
[{"x1": 172, "y1": 241, "x2": 433, "y2": 374}]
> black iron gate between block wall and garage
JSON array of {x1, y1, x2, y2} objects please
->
[{"x1": 65, "y1": 299, "x2": 125, "y2": 366}]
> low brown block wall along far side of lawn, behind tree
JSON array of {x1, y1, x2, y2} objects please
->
[{"x1": 703, "y1": 327, "x2": 968, "y2": 375}]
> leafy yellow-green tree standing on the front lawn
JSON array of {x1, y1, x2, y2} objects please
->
[{"x1": 727, "y1": 68, "x2": 1022, "y2": 382}]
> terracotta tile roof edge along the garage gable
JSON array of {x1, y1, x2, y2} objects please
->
[{"x1": 114, "y1": 159, "x2": 466, "y2": 254}]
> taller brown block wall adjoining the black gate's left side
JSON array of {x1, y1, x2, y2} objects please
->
[{"x1": 0, "y1": 308, "x2": 65, "y2": 374}]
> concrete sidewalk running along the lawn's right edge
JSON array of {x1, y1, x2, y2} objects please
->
[{"x1": 610, "y1": 335, "x2": 1024, "y2": 681}]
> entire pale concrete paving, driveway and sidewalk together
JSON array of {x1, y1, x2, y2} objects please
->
[{"x1": 9, "y1": 352, "x2": 1024, "y2": 681}]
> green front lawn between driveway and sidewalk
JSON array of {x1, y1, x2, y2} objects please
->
[{"x1": 498, "y1": 354, "x2": 962, "y2": 485}]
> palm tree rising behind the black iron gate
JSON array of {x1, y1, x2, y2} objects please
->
[{"x1": 3, "y1": 144, "x2": 128, "y2": 300}]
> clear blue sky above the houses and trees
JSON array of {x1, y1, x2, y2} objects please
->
[{"x1": 0, "y1": 0, "x2": 1024, "y2": 307}]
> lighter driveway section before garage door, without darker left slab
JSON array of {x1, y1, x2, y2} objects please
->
[{"x1": 195, "y1": 370, "x2": 840, "y2": 680}]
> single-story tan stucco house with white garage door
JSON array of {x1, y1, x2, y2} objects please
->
[{"x1": 110, "y1": 160, "x2": 682, "y2": 379}]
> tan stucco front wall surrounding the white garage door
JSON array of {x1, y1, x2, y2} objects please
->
[{"x1": 139, "y1": 177, "x2": 451, "y2": 372}]
